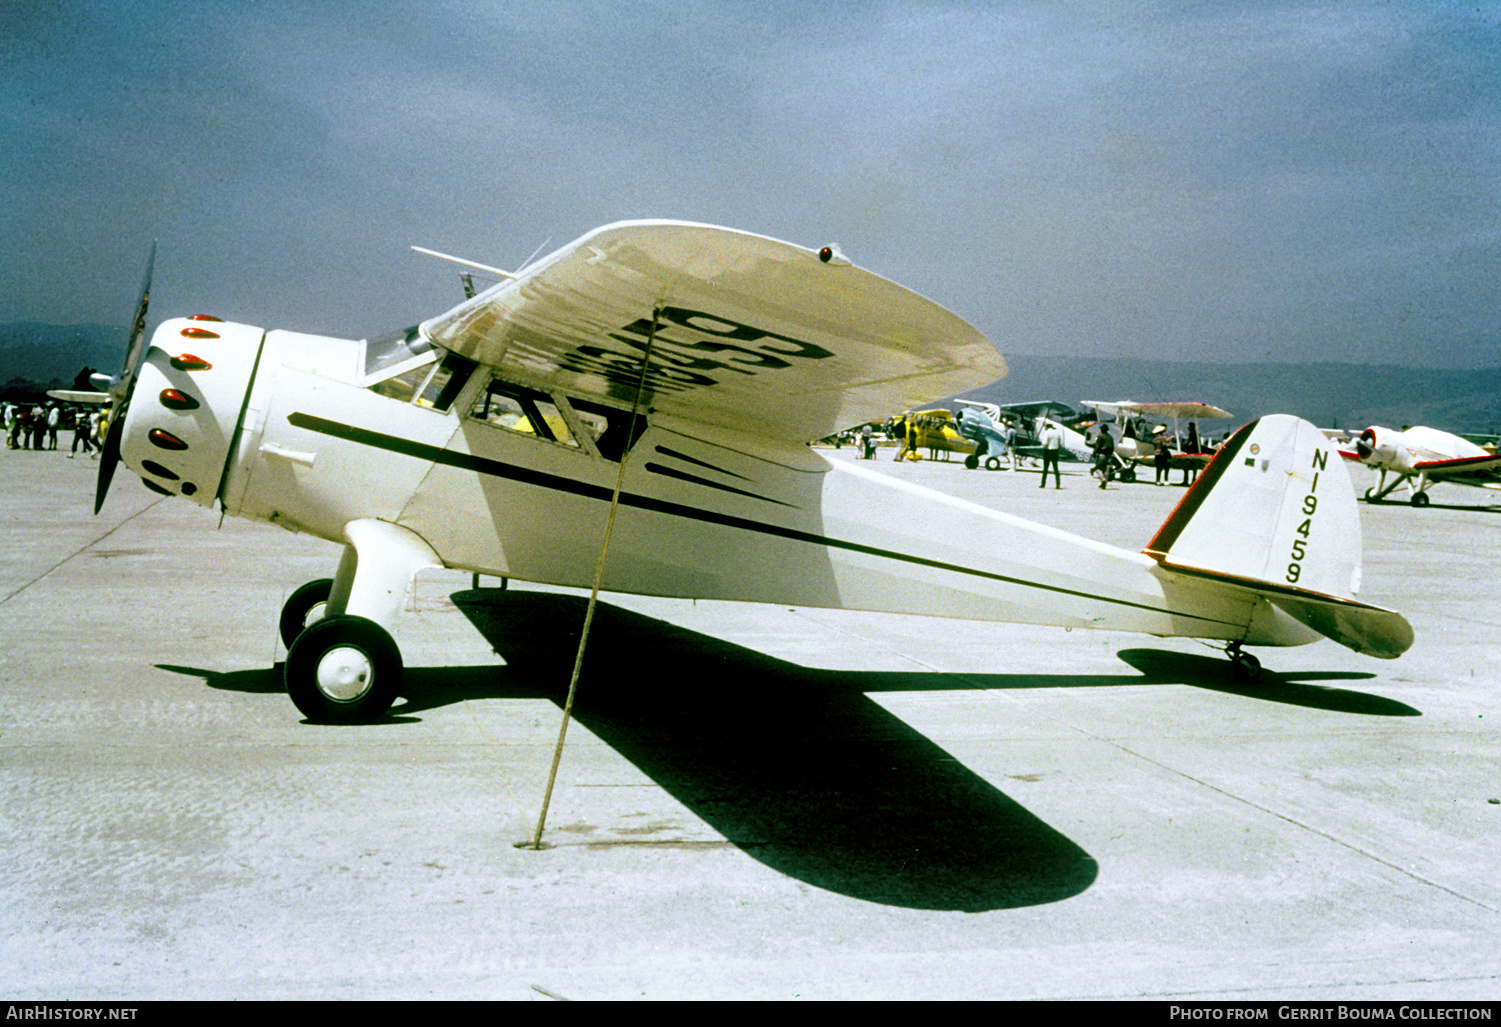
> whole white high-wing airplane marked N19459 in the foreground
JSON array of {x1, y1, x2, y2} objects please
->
[{"x1": 96, "y1": 221, "x2": 1412, "y2": 721}]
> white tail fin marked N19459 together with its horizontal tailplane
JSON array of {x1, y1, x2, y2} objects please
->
[{"x1": 1145, "y1": 414, "x2": 1412, "y2": 658}]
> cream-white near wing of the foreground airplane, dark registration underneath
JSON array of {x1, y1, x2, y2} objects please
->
[{"x1": 422, "y1": 221, "x2": 1006, "y2": 441}]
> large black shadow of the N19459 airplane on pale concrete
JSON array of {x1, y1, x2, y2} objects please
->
[{"x1": 164, "y1": 589, "x2": 1417, "y2": 911}]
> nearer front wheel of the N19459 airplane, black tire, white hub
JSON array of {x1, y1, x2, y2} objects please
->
[{"x1": 284, "y1": 614, "x2": 402, "y2": 724}]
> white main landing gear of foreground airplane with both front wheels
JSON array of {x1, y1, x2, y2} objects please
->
[{"x1": 282, "y1": 520, "x2": 443, "y2": 724}]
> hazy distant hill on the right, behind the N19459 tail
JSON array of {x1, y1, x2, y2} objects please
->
[{"x1": 934, "y1": 354, "x2": 1501, "y2": 434}]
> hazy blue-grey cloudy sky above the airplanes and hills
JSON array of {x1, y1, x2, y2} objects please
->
[{"x1": 0, "y1": 0, "x2": 1501, "y2": 368}]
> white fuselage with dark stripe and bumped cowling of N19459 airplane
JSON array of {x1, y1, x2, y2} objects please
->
[{"x1": 122, "y1": 321, "x2": 1318, "y2": 644}]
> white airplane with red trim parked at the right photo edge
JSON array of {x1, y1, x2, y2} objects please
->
[{"x1": 1340, "y1": 426, "x2": 1501, "y2": 506}]
